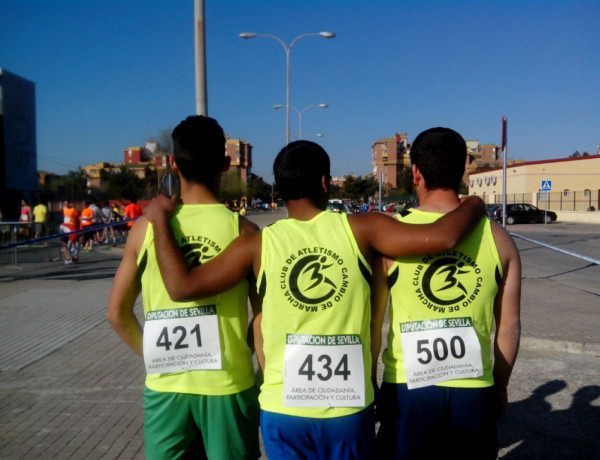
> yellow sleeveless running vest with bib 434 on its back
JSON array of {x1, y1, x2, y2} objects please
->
[{"x1": 258, "y1": 211, "x2": 373, "y2": 418}]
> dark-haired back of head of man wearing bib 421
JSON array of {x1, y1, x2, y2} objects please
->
[{"x1": 171, "y1": 115, "x2": 225, "y2": 186}]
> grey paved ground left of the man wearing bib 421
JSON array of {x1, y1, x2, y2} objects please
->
[{"x1": 0, "y1": 252, "x2": 144, "y2": 459}]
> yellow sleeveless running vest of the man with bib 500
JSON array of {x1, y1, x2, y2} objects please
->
[{"x1": 383, "y1": 209, "x2": 503, "y2": 388}]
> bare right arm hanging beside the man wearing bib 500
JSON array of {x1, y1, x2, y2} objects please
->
[{"x1": 492, "y1": 222, "x2": 521, "y2": 415}]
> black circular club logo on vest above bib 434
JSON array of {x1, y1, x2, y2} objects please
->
[{"x1": 280, "y1": 249, "x2": 348, "y2": 311}]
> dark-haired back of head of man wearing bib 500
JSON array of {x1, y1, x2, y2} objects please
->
[{"x1": 410, "y1": 127, "x2": 467, "y2": 192}]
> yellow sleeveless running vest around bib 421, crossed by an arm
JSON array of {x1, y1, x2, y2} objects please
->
[{"x1": 137, "y1": 204, "x2": 255, "y2": 395}]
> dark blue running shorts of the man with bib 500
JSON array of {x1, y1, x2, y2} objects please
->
[{"x1": 377, "y1": 382, "x2": 499, "y2": 460}]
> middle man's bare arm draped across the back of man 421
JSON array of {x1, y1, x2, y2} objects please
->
[{"x1": 144, "y1": 195, "x2": 260, "y2": 301}]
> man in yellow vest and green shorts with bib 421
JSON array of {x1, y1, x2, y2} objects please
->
[{"x1": 107, "y1": 116, "x2": 260, "y2": 460}]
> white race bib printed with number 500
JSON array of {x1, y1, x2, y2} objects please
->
[{"x1": 400, "y1": 317, "x2": 483, "y2": 389}]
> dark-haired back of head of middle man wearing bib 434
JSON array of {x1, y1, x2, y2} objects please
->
[{"x1": 273, "y1": 141, "x2": 330, "y2": 205}]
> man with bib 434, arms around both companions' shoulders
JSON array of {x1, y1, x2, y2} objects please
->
[{"x1": 145, "y1": 141, "x2": 485, "y2": 460}]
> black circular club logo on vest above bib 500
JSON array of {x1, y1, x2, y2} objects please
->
[{"x1": 413, "y1": 254, "x2": 483, "y2": 312}]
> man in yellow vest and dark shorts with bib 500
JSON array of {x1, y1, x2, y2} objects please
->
[{"x1": 372, "y1": 128, "x2": 521, "y2": 459}]
